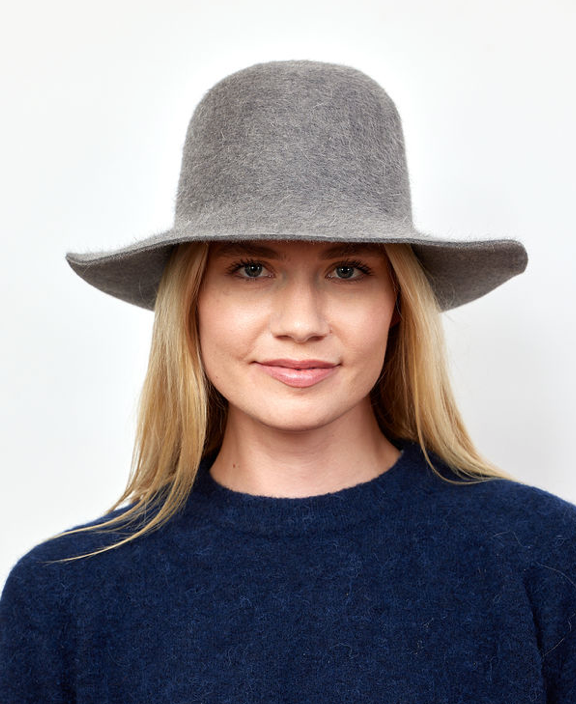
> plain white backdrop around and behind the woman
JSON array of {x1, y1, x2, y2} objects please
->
[{"x1": 0, "y1": 0, "x2": 576, "y2": 584}]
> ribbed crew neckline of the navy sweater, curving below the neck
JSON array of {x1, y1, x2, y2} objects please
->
[{"x1": 190, "y1": 440, "x2": 427, "y2": 535}]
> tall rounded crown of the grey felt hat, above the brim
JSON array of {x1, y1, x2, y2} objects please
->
[{"x1": 175, "y1": 61, "x2": 412, "y2": 232}]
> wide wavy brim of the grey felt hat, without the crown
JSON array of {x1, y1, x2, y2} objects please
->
[{"x1": 66, "y1": 213, "x2": 528, "y2": 311}]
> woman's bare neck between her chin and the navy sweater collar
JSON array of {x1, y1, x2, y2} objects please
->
[{"x1": 210, "y1": 399, "x2": 400, "y2": 498}]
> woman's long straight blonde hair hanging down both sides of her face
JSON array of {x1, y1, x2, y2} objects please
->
[{"x1": 56, "y1": 242, "x2": 518, "y2": 560}]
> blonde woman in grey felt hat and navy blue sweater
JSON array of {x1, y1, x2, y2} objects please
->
[{"x1": 0, "y1": 61, "x2": 576, "y2": 704}]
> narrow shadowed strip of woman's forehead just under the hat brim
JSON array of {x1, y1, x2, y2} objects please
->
[{"x1": 210, "y1": 240, "x2": 385, "y2": 260}]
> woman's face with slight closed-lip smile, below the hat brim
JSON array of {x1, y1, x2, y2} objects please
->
[{"x1": 198, "y1": 241, "x2": 396, "y2": 431}]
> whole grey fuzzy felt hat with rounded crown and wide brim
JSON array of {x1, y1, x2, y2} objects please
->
[{"x1": 66, "y1": 61, "x2": 528, "y2": 310}]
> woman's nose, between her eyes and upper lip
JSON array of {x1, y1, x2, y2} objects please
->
[{"x1": 270, "y1": 277, "x2": 330, "y2": 343}]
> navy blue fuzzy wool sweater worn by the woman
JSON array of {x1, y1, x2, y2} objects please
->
[{"x1": 0, "y1": 443, "x2": 576, "y2": 704}]
